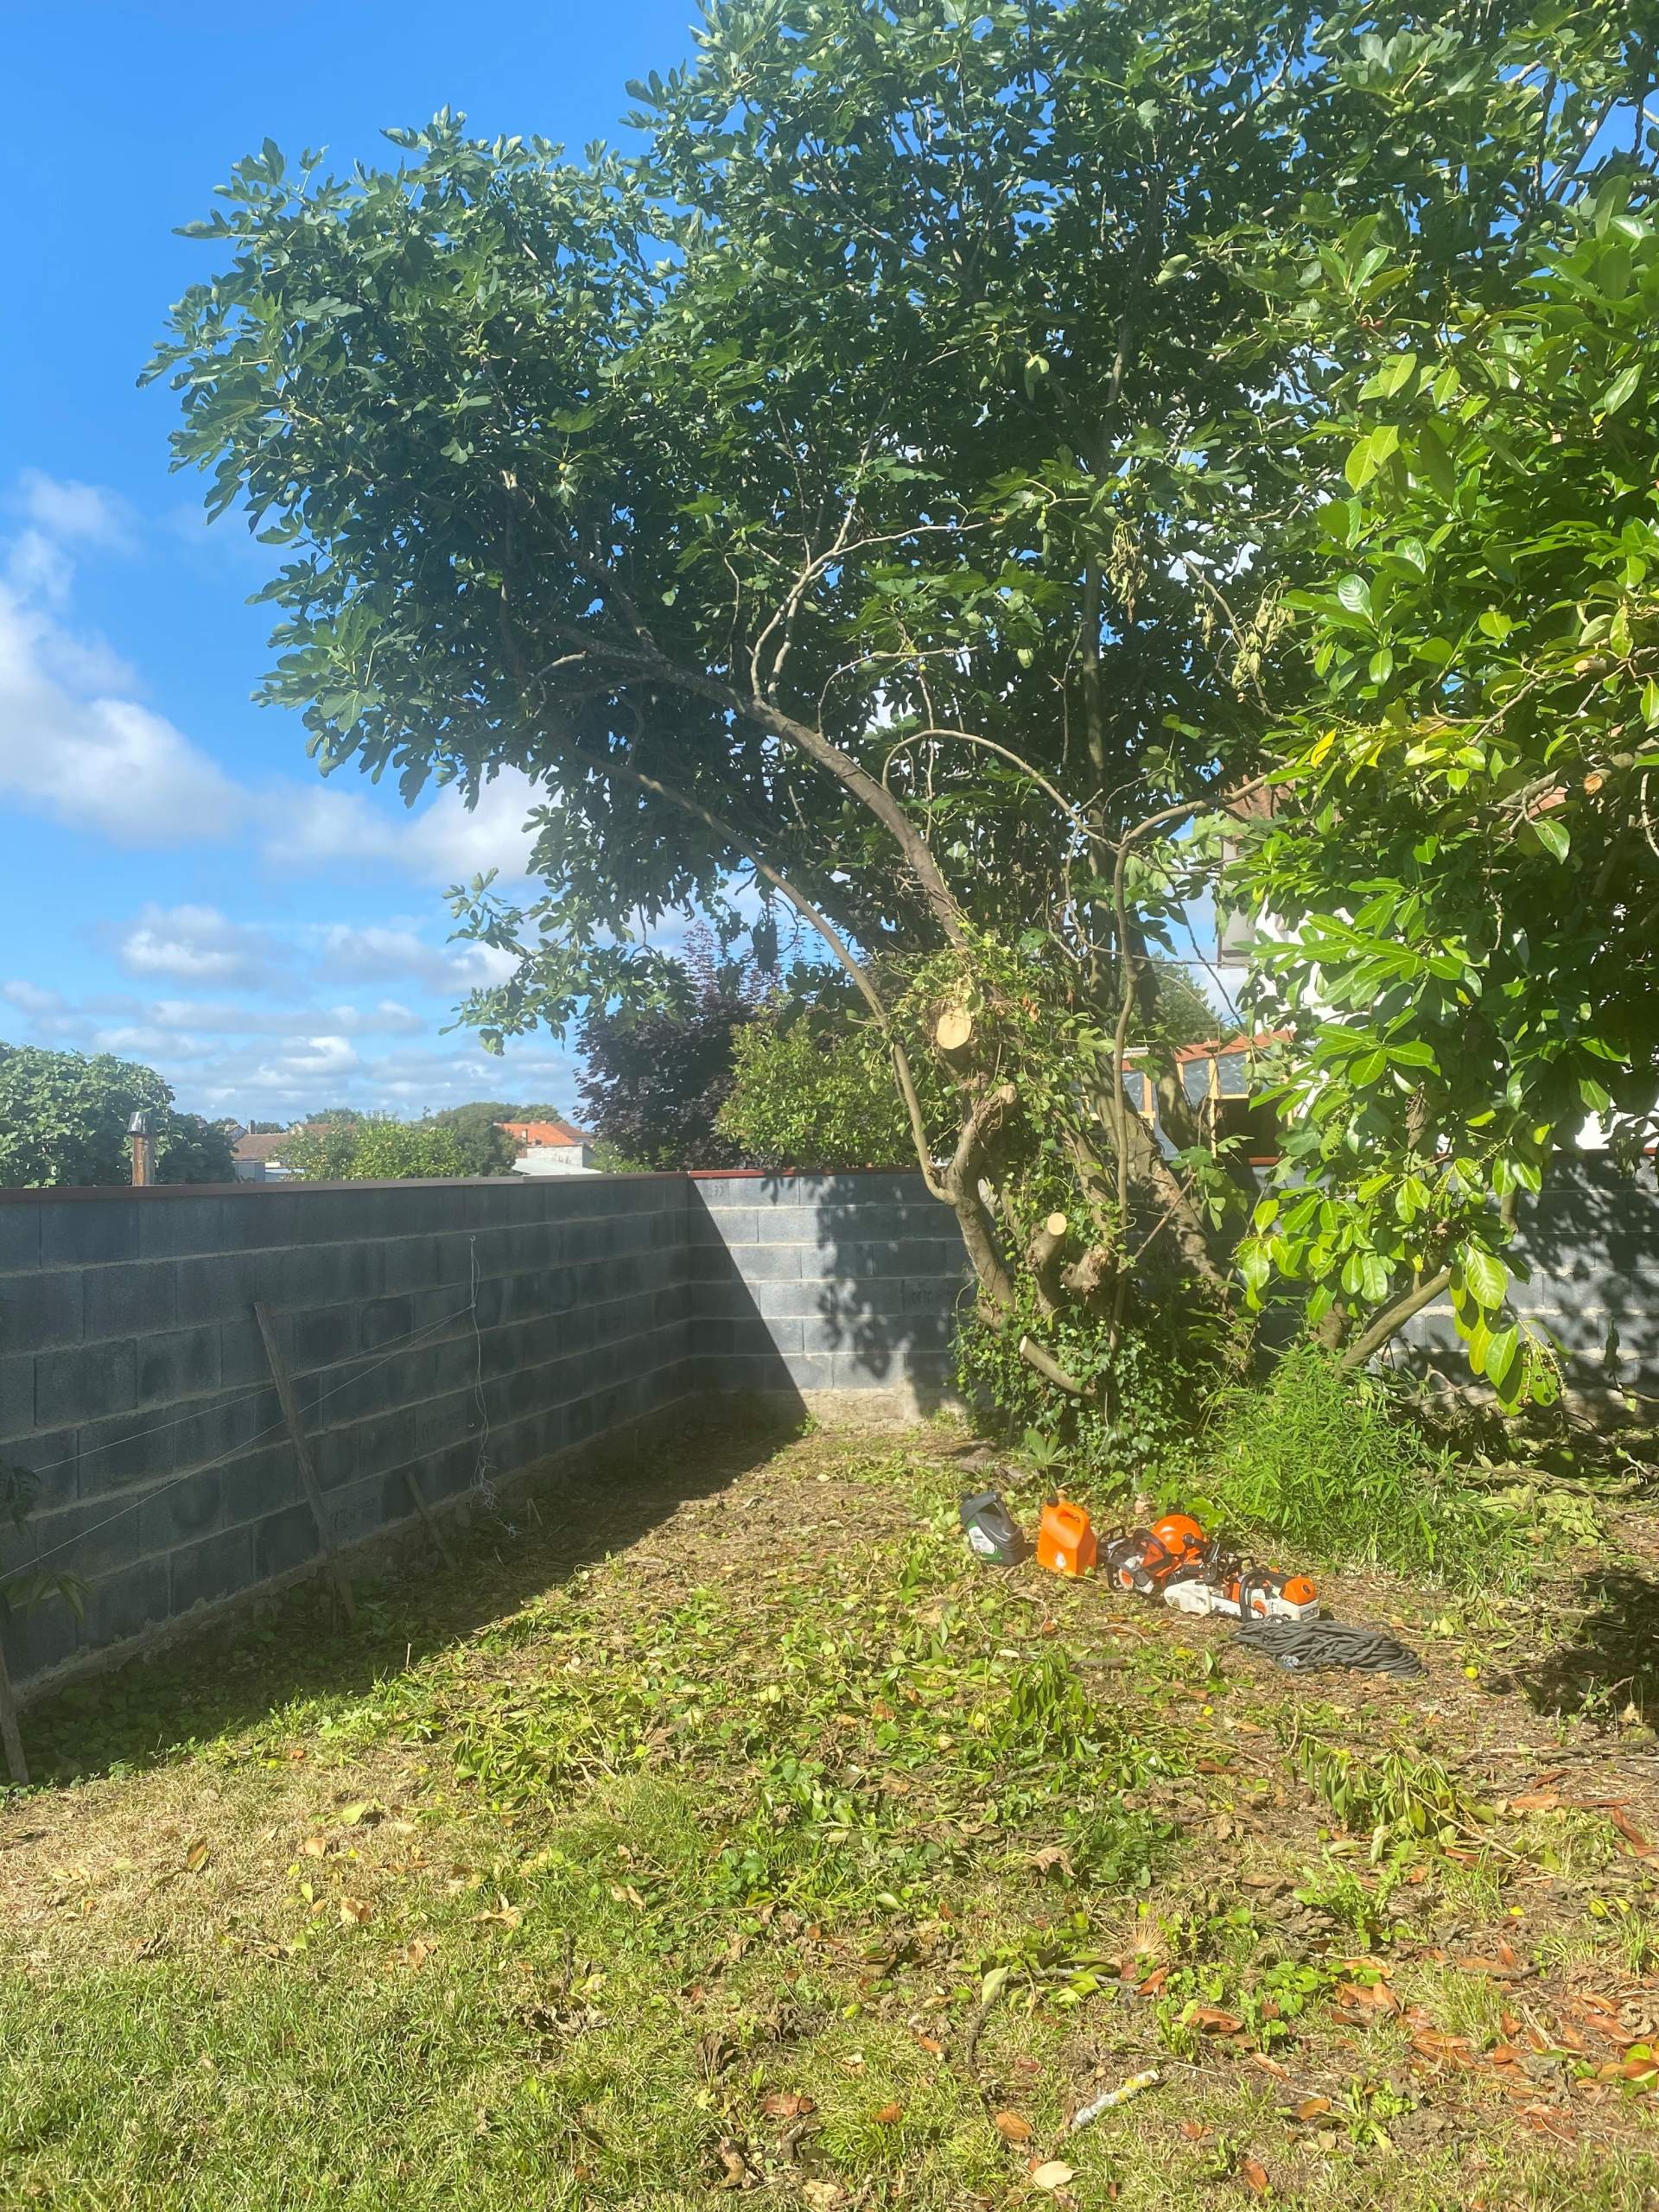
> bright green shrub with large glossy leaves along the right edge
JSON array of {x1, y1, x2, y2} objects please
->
[{"x1": 1241, "y1": 133, "x2": 1659, "y2": 1407}]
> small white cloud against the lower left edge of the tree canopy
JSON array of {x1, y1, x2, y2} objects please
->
[{"x1": 265, "y1": 767, "x2": 546, "y2": 885}]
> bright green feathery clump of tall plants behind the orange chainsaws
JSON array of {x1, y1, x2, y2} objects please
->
[{"x1": 1192, "y1": 1344, "x2": 1516, "y2": 1584}]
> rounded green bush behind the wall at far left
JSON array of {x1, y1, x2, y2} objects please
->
[{"x1": 0, "y1": 1044, "x2": 234, "y2": 1190}]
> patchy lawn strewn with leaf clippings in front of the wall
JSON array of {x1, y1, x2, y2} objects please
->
[{"x1": 0, "y1": 1429, "x2": 1659, "y2": 2212}]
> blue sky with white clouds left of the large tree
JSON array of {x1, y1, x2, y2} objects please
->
[{"x1": 0, "y1": 0, "x2": 692, "y2": 1119}]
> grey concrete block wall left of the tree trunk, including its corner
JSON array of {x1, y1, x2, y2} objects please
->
[{"x1": 0, "y1": 1174, "x2": 963, "y2": 1686}]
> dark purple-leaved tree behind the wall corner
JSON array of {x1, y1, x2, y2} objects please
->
[{"x1": 577, "y1": 931, "x2": 772, "y2": 1170}]
